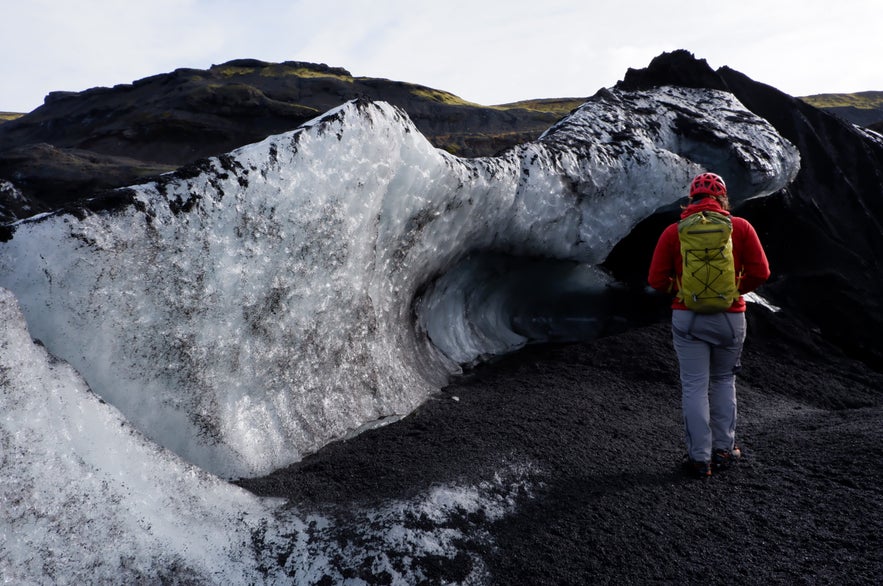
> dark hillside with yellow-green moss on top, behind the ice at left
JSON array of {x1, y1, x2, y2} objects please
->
[{"x1": 0, "y1": 59, "x2": 583, "y2": 221}]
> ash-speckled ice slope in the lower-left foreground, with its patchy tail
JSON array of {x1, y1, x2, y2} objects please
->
[{"x1": 0, "y1": 282, "x2": 531, "y2": 585}]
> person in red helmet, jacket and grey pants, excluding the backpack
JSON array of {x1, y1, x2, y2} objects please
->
[{"x1": 647, "y1": 173, "x2": 770, "y2": 478}]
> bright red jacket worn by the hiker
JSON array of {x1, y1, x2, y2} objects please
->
[{"x1": 647, "y1": 197, "x2": 770, "y2": 312}]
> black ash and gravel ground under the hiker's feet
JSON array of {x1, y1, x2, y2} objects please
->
[{"x1": 240, "y1": 306, "x2": 883, "y2": 584}]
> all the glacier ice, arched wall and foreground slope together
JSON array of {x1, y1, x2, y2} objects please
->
[{"x1": 0, "y1": 87, "x2": 799, "y2": 583}]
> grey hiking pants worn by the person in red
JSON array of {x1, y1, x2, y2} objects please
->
[{"x1": 671, "y1": 309, "x2": 746, "y2": 462}]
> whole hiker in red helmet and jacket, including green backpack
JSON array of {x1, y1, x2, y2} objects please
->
[{"x1": 647, "y1": 173, "x2": 770, "y2": 478}]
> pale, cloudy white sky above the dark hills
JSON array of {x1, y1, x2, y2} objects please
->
[{"x1": 0, "y1": 0, "x2": 883, "y2": 112}]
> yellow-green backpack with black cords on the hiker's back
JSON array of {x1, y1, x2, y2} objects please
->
[{"x1": 678, "y1": 211, "x2": 739, "y2": 313}]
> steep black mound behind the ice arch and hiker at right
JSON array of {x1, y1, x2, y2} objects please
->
[{"x1": 608, "y1": 51, "x2": 883, "y2": 367}]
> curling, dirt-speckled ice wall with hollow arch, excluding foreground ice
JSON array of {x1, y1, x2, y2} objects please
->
[{"x1": 0, "y1": 87, "x2": 799, "y2": 477}]
